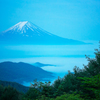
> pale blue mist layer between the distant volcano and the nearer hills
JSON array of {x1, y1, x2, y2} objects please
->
[{"x1": 0, "y1": 43, "x2": 98, "y2": 86}]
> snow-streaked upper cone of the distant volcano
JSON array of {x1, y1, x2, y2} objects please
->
[{"x1": 3, "y1": 21, "x2": 52, "y2": 36}]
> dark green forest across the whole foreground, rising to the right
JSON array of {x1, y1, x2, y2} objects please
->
[{"x1": 0, "y1": 46, "x2": 100, "y2": 100}]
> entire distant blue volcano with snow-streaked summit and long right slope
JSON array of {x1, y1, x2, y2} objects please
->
[{"x1": 0, "y1": 21, "x2": 85, "y2": 45}]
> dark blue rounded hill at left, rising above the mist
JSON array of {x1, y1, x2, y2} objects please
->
[{"x1": 0, "y1": 62, "x2": 53, "y2": 84}]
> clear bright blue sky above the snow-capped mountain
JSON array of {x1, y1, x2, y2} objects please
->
[{"x1": 0, "y1": 0, "x2": 100, "y2": 41}]
